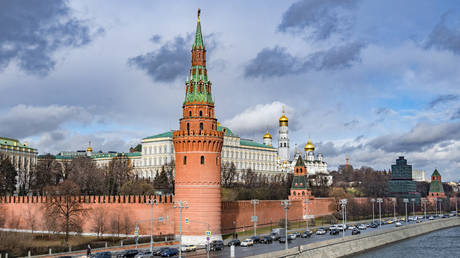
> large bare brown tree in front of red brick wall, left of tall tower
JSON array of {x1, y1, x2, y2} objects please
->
[{"x1": 45, "y1": 180, "x2": 88, "y2": 245}]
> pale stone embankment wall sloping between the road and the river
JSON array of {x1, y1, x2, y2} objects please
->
[{"x1": 253, "y1": 217, "x2": 460, "y2": 258}]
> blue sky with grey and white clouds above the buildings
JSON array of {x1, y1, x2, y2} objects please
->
[{"x1": 0, "y1": 0, "x2": 460, "y2": 180}]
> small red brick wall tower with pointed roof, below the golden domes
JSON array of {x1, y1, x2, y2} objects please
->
[{"x1": 289, "y1": 156, "x2": 313, "y2": 200}]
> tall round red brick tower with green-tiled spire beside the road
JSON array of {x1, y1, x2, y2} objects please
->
[{"x1": 173, "y1": 9, "x2": 224, "y2": 244}]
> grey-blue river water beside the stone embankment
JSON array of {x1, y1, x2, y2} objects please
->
[{"x1": 354, "y1": 227, "x2": 460, "y2": 258}]
